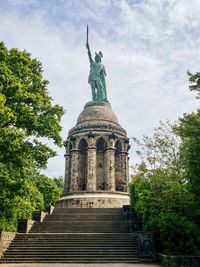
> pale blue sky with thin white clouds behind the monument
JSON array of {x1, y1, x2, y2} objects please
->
[{"x1": 0, "y1": 0, "x2": 200, "y2": 180}]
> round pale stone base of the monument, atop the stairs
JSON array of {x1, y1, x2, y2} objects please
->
[{"x1": 55, "y1": 191, "x2": 130, "y2": 208}]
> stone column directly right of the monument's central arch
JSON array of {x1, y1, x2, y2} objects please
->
[{"x1": 105, "y1": 148, "x2": 115, "y2": 191}]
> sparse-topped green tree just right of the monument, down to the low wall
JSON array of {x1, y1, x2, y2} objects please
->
[{"x1": 130, "y1": 122, "x2": 200, "y2": 254}]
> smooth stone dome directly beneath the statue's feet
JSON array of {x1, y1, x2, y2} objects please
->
[{"x1": 76, "y1": 102, "x2": 118, "y2": 125}]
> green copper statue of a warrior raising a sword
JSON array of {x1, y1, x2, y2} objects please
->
[{"x1": 86, "y1": 26, "x2": 108, "y2": 103}]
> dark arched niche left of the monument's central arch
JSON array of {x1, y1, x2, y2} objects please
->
[{"x1": 77, "y1": 139, "x2": 88, "y2": 190}]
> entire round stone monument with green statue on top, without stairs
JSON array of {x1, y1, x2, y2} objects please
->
[{"x1": 56, "y1": 27, "x2": 130, "y2": 208}]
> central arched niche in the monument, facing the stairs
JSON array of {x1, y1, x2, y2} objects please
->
[{"x1": 96, "y1": 137, "x2": 107, "y2": 190}]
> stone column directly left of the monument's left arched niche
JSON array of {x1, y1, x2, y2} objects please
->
[{"x1": 70, "y1": 150, "x2": 79, "y2": 193}]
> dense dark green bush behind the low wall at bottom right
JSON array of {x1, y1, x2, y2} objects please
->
[{"x1": 144, "y1": 213, "x2": 200, "y2": 255}]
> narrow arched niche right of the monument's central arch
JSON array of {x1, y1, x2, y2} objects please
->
[{"x1": 115, "y1": 140, "x2": 124, "y2": 192}]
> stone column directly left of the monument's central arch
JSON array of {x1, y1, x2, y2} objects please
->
[{"x1": 87, "y1": 146, "x2": 97, "y2": 191}]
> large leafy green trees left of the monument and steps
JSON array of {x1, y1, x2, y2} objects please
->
[{"x1": 0, "y1": 42, "x2": 64, "y2": 231}]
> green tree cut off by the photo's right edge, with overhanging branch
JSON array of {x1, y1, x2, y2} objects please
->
[{"x1": 176, "y1": 72, "x2": 200, "y2": 226}]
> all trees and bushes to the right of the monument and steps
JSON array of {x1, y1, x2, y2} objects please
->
[{"x1": 130, "y1": 73, "x2": 200, "y2": 255}]
